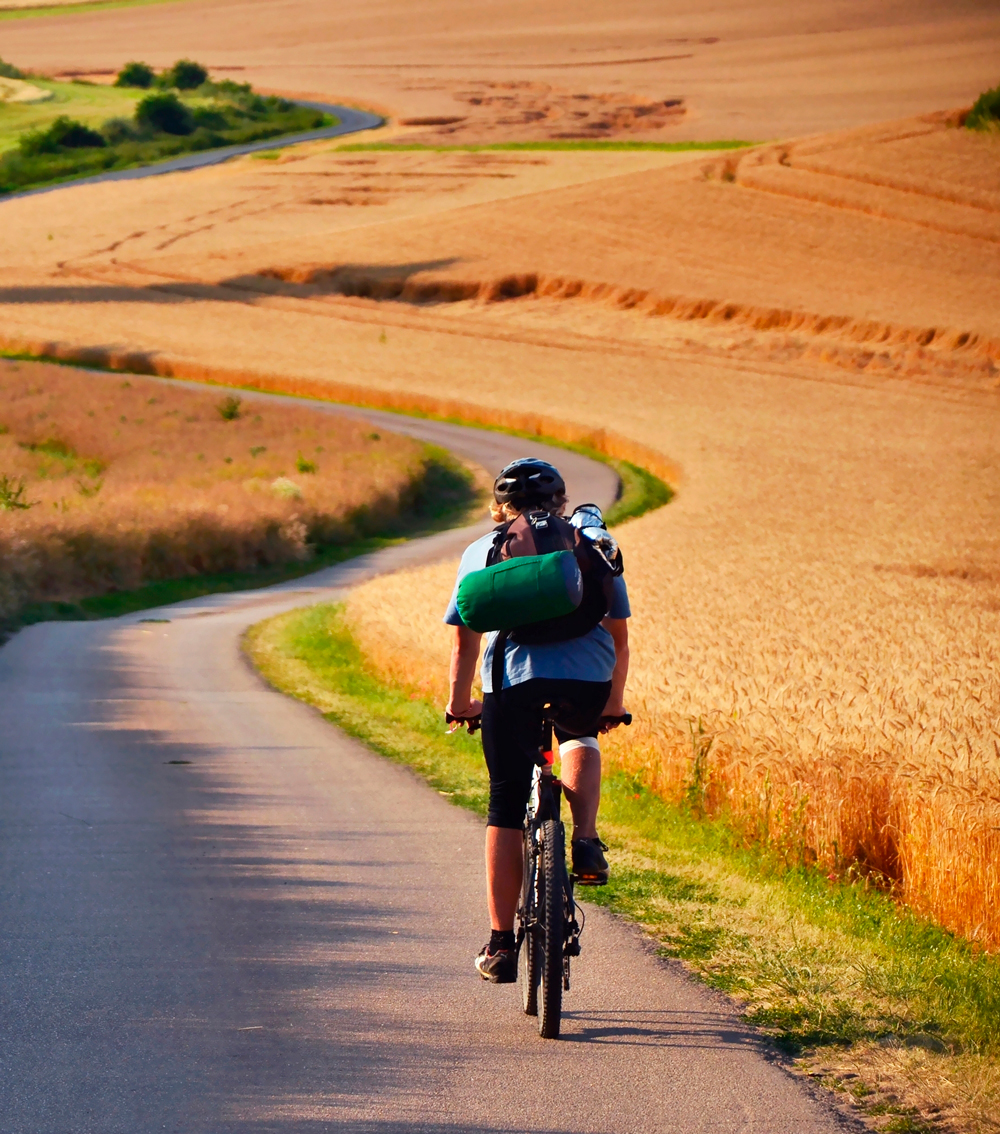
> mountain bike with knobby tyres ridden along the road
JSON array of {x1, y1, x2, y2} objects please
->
[{"x1": 444, "y1": 713, "x2": 632, "y2": 1040}]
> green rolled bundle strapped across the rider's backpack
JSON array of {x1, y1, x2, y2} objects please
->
[{"x1": 456, "y1": 551, "x2": 583, "y2": 633}]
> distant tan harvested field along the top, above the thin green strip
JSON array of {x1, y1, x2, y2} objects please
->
[{"x1": 3, "y1": 0, "x2": 1000, "y2": 141}]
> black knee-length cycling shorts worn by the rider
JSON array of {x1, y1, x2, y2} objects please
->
[{"x1": 483, "y1": 677, "x2": 611, "y2": 830}]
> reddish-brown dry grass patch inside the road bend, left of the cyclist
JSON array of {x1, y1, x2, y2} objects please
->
[{"x1": 0, "y1": 362, "x2": 424, "y2": 619}]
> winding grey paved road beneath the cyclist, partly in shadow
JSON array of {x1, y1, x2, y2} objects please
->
[{"x1": 0, "y1": 414, "x2": 844, "y2": 1134}]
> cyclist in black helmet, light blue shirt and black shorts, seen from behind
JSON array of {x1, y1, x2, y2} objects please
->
[{"x1": 444, "y1": 458, "x2": 632, "y2": 984}]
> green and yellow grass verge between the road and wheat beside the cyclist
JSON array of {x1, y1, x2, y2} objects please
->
[{"x1": 246, "y1": 606, "x2": 1000, "y2": 1134}]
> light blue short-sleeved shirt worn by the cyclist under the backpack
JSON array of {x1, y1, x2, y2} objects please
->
[{"x1": 444, "y1": 532, "x2": 632, "y2": 693}]
